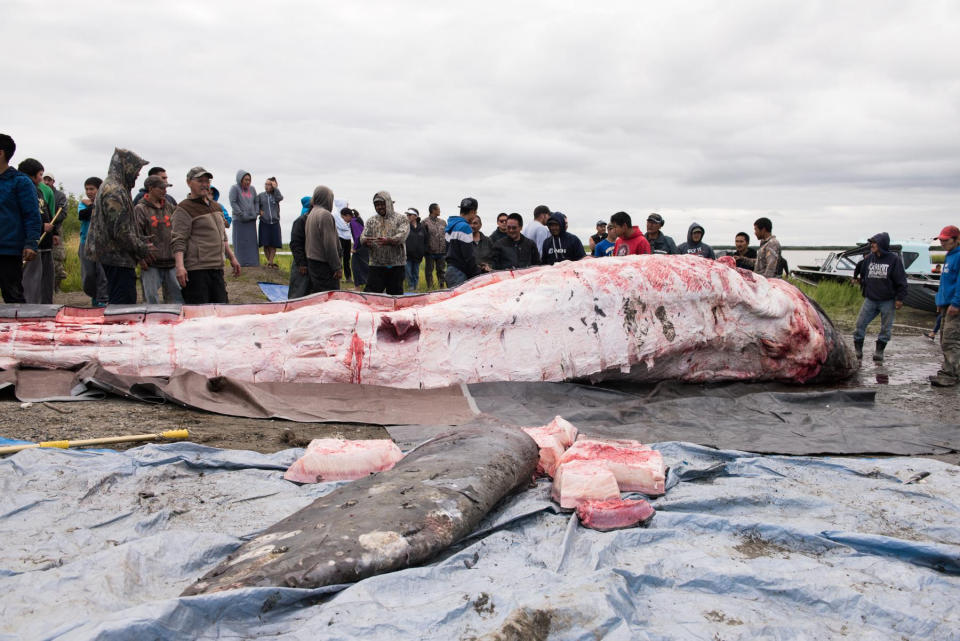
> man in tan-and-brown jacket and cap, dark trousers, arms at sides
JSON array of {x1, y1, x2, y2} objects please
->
[{"x1": 171, "y1": 167, "x2": 240, "y2": 305}]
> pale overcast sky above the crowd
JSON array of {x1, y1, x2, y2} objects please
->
[{"x1": 0, "y1": 0, "x2": 960, "y2": 244}]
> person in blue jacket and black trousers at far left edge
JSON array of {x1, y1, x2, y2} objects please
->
[{"x1": 0, "y1": 134, "x2": 41, "y2": 303}]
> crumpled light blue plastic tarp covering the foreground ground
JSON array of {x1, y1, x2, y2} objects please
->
[{"x1": 0, "y1": 443, "x2": 960, "y2": 641}]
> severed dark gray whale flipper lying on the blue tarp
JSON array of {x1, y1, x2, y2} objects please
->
[{"x1": 183, "y1": 425, "x2": 539, "y2": 596}]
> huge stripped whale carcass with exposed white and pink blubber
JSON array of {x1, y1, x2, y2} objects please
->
[{"x1": 0, "y1": 255, "x2": 856, "y2": 388}]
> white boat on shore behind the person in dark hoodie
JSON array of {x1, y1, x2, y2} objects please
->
[{"x1": 790, "y1": 241, "x2": 940, "y2": 312}]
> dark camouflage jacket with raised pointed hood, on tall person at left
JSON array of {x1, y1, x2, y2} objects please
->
[{"x1": 84, "y1": 149, "x2": 148, "y2": 269}]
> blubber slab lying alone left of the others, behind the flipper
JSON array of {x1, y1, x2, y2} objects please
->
[{"x1": 283, "y1": 438, "x2": 403, "y2": 483}]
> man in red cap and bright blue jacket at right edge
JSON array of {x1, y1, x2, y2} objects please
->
[{"x1": 930, "y1": 225, "x2": 960, "y2": 387}]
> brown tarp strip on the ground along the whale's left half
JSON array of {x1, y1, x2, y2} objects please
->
[{"x1": 0, "y1": 363, "x2": 475, "y2": 425}]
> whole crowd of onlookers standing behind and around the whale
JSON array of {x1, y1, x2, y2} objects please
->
[{"x1": 0, "y1": 134, "x2": 960, "y2": 386}]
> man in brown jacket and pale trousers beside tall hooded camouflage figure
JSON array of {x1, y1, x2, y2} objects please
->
[{"x1": 133, "y1": 176, "x2": 183, "y2": 305}]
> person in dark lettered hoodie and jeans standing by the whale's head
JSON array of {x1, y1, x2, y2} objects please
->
[{"x1": 853, "y1": 232, "x2": 907, "y2": 363}]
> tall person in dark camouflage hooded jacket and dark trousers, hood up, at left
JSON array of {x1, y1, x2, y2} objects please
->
[{"x1": 86, "y1": 149, "x2": 153, "y2": 305}]
